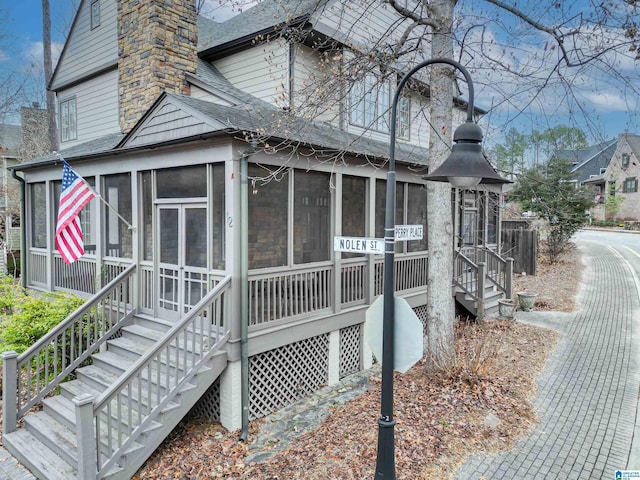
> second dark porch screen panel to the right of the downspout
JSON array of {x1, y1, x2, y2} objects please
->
[{"x1": 293, "y1": 170, "x2": 331, "y2": 264}]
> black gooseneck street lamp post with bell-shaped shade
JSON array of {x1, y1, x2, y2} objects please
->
[{"x1": 375, "y1": 58, "x2": 508, "y2": 480}]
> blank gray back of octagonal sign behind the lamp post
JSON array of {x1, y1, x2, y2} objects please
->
[{"x1": 364, "y1": 295, "x2": 424, "y2": 373}]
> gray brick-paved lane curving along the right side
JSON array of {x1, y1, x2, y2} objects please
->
[{"x1": 454, "y1": 242, "x2": 640, "y2": 480}]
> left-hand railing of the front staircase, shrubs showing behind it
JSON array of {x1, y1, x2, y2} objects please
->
[{"x1": 2, "y1": 265, "x2": 136, "y2": 433}]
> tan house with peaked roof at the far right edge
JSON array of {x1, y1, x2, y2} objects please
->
[{"x1": 581, "y1": 133, "x2": 640, "y2": 221}]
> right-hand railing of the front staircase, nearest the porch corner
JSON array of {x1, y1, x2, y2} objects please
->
[{"x1": 87, "y1": 277, "x2": 231, "y2": 478}]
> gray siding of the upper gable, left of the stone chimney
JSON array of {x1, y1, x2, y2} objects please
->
[{"x1": 52, "y1": 0, "x2": 118, "y2": 90}]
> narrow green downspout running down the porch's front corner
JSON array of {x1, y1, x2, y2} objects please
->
[{"x1": 240, "y1": 153, "x2": 249, "y2": 442}]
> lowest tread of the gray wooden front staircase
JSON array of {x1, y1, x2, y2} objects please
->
[{"x1": 3, "y1": 428, "x2": 78, "y2": 480}]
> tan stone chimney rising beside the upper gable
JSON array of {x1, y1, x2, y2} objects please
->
[{"x1": 118, "y1": 0, "x2": 198, "y2": 133}]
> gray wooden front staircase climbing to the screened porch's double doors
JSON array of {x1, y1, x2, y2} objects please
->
[{"x1": 3, "y1": 268, "x2": 230, "y2": 480}]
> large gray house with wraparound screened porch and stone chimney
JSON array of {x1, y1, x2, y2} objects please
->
[{"x1": 3, "y1": 0, "x2": 510, "y2": 478}]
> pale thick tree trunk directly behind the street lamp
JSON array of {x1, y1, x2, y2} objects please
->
[{"x1": 427, "y1": 0, "x2": 456, "y2": 368}]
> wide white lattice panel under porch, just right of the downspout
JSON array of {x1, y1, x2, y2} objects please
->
[{"x1": 249, "y1": 334, "x2": 329, "y2": 420}]
